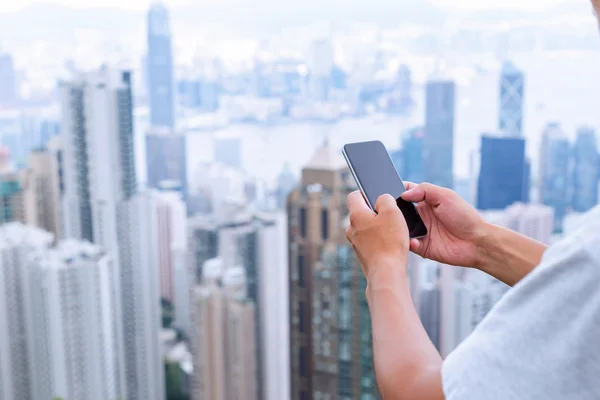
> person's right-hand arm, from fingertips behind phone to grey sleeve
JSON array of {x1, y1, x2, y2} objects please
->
[{"x1": 402, "y1": 183, "x2": 546, "y2": 286}]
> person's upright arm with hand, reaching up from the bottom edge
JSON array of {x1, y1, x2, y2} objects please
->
[{"x1": 346, "y1": 192, "x2": 444, "y2": 400}]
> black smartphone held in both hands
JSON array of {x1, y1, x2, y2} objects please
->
[{"x1": 342, "y1": 140, "x2": 427, "y2": 238}]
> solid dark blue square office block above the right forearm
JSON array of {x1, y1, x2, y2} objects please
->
[{"x1": 477, "y1": 134, "x2": 529, "y2": 210}]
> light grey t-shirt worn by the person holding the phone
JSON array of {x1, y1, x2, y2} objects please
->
[{"x1": 442, "y1": 208, "x2": 600, "y2": 400}]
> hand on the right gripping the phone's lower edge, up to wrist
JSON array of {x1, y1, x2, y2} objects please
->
[{"x1": 402, "y1": 182, "x2": 487, "y2": 267}]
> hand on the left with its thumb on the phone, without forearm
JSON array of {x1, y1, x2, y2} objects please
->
[{"x1": 346, "y1": 191, "x2": 409, "y2": 283}]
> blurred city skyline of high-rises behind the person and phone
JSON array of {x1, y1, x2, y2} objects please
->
[{"x1": 0, "y1": 0, "x2": 600, "y2": 400}]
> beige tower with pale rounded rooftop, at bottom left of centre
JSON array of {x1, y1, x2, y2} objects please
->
[{"x1": 194, "y1": 259, "x2": 259, "y2": 400}]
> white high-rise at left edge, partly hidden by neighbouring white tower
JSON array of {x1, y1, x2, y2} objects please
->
[{"x1": 0, "y1": 223, "x2": 53, "y2": 400}]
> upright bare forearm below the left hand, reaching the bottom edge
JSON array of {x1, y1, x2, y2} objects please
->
[{"x1": 367, "y1": 266, "x2": 444, "y2": 400}]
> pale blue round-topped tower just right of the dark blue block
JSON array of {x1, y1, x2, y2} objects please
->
[{"x1": 539, "y1": 123, "x2": 571, "y2": 232}]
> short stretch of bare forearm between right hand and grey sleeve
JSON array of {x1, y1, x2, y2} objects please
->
[{"x1": 476, "y1": 225, "x2": 547, "y2": 286}]
